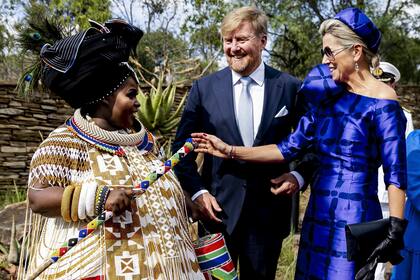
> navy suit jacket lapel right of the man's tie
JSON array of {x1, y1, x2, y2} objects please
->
[{"x1": 254, "y1": 65, "x2": 283, "y2": 146}]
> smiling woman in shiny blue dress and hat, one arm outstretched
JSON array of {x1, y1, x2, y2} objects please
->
[{"x1": 193, "y1": 8, "x2": 406, "y2": 280}]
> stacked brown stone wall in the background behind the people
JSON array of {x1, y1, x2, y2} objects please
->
[{"x1": 0, "y1": 82, "x2": 420, "y2": 191}]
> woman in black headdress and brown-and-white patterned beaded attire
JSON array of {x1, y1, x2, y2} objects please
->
[{"x1": 19, "y1": 21, "x2": 203, "y2": 279}]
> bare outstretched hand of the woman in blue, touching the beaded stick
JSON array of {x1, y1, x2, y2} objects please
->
[{"x1": 191, "y1": 133, "x2": 233, "y2": 158}]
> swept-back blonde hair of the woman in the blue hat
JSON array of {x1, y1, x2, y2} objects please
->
[{"x1": 319, "y1": 19, "x2": 379, "y2": 68}]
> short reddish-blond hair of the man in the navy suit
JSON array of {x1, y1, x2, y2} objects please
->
[{"x1": 220, "y1": 6, "x2": 268, "y2": 36}]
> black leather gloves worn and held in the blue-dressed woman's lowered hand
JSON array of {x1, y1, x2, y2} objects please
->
[{"x1": 355, "y1": 217, "x2": 408, "y2": 280}]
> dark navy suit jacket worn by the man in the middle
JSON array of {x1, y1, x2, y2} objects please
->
[{"x1": 173, "y1": 65, "x2": 314, "y2": 236}]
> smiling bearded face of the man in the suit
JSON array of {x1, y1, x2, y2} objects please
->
[{"x1": 223, "y1": 21, "x2": 267, "y2": 76}]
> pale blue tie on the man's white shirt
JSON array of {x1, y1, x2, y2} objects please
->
[{"x1": 237, "y1": 77, "x2": 254, "y2": 147}]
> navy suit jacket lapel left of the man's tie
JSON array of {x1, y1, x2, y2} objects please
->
[{"x1": 213, "y1": 67, "x2": 243, "y2": 145}]
